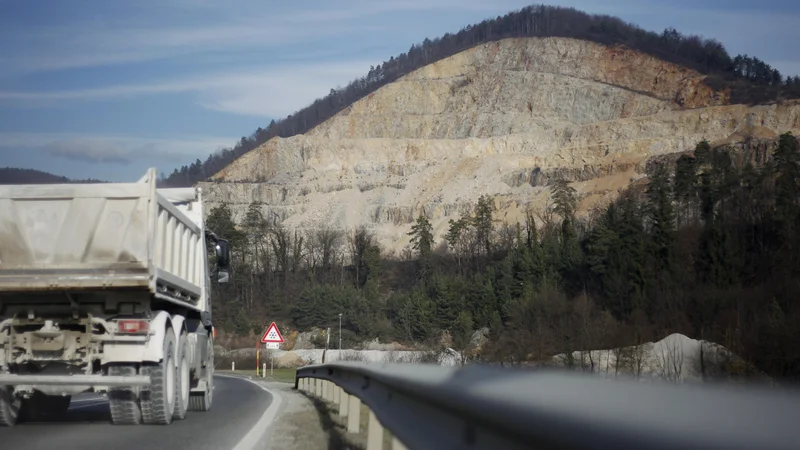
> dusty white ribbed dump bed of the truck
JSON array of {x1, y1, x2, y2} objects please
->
[{"x1": 0, "y1": 169, "x2": 207, "y2": 311}]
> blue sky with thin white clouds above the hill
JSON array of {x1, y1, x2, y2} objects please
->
[{"x1": 0, "y1": 0, "x2": 800, "y2": 181}]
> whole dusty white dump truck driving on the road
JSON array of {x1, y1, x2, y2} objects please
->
[{"x1": 0, "y1": 169, "x2": 230, "y2": 426}]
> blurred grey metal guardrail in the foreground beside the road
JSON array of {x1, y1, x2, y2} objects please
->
[{"x1": 295, "y1": 362, "x2": 800, "y2": 450}]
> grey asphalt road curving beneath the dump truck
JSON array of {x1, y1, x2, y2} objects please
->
[{"x1": 0, "y1": 376, "x2": 272, "y2": 450}]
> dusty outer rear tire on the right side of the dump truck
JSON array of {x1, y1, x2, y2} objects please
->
[{"x1": 140, "y1": 328, "x2": 177, "y2": 425}]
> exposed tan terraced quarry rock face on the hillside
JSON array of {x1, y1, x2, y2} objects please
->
[{"x1": 201, "y1": 38, "x2": 800, "y2": 252}]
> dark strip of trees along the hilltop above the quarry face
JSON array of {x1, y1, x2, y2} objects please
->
[{"x1": 162, "y1": 6, "x2": 800, "y2": 186}]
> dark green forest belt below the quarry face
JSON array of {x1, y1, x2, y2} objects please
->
[{"x1": 207, "y1": 133, "x2": 800, "y2": 381}]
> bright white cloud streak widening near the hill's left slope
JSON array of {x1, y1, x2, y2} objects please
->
[{"x1": 0, "y1": 61, "x2": 378, "y2": 117}]
